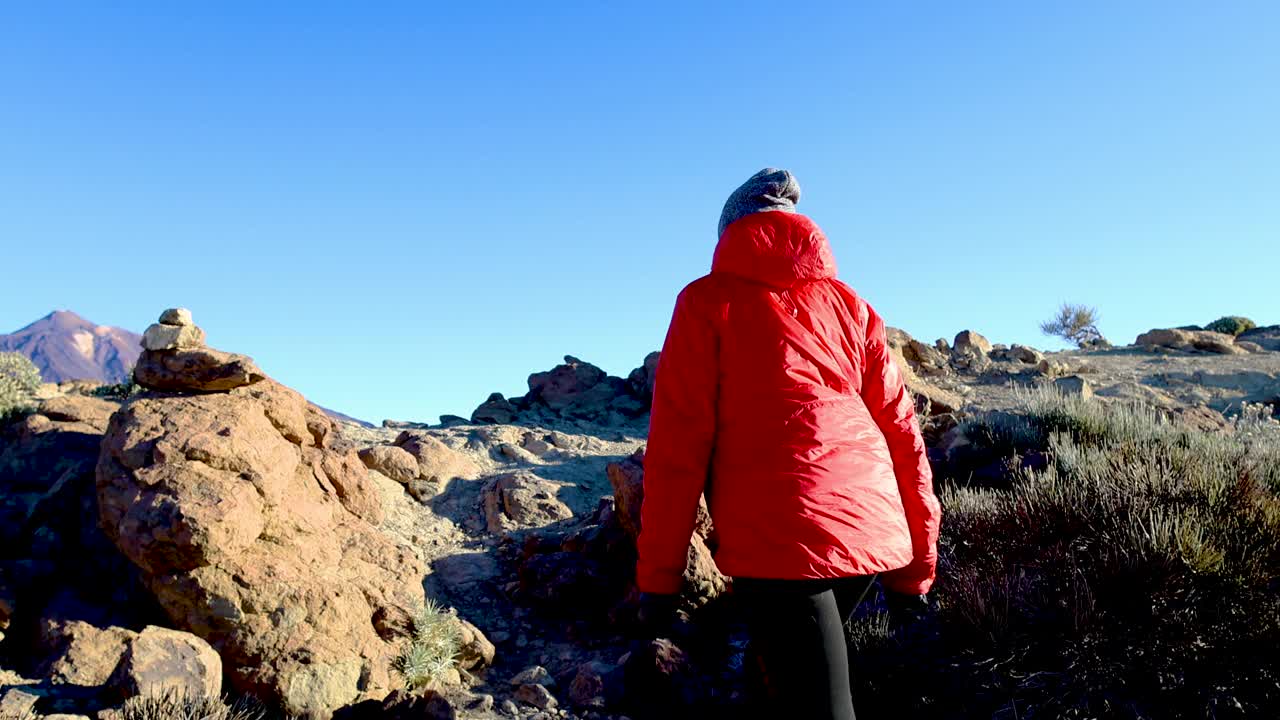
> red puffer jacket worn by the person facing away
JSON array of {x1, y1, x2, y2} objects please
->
[{"x1": 636, "y1": 211, "x2": 941, "y2": 593}]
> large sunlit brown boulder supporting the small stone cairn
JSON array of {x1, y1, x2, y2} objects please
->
[{"x1": 97, "y1": 371, "x2": 425, "y2": 717}]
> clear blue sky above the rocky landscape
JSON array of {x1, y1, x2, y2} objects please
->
[{"x1": 0, "y1": 0, "x2": 1280, "y2": 421}]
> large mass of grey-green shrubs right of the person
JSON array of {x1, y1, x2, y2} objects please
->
[{"x1": 854, "y1": 391, "x2": 1280, "y2": 719}]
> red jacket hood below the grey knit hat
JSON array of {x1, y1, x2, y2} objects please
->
[{"x1": 712, "y1": 211, "x2": 836, "y2": 288}]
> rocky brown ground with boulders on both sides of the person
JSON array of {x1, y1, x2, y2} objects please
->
[{"x1": 0, "y1": 310, "x2": 1280, "y2": 719}]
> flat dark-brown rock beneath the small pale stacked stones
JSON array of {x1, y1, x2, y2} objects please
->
[{"x1": 133, "y1": 347, "x2": 266, "y2": 392}]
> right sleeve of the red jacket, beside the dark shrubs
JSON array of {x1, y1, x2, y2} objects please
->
[{"x1": 863, "y1": 299, "x2": 942, "y2": 594}]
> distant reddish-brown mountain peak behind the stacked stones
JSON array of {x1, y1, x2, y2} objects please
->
[{"x1": 0, "y1": 310, "x2": 142, "y2": 383}]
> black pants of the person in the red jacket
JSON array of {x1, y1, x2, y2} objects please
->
[{"x1": 733, "y1": 575, "x2": 876, "y2": 720}]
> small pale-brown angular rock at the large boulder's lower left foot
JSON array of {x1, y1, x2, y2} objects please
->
[{"x1": 108, "y1": 625, "x2": 223, "y2": 700}]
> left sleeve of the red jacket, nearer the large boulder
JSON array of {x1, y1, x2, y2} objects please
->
[{"x1": 636, "y1": 288, "x2": 719, "y2": 594}]
